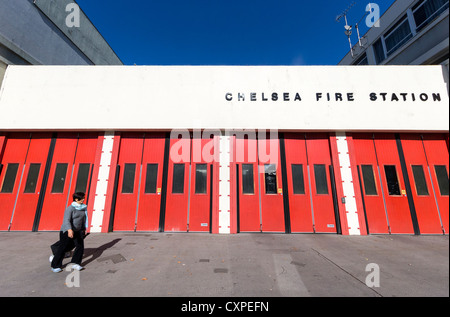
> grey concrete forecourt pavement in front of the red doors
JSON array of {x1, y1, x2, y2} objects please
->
[{"x1": 0, "y1": 232, "x2": 449, "y2": 298}]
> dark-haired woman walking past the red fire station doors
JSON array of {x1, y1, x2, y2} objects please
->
[{"x1": 51, "y1": 192, "x2": 88, "y2": 273}]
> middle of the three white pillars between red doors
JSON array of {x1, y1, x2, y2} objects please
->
[{"x1": 219, "y1": 134, "x2": 231, "y2": 234}]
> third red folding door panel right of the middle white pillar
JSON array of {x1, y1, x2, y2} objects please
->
[{"x1": 284, "y1": 133, "x2": 314, "y2": 233}]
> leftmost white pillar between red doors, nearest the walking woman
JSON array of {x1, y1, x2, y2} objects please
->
[{"x1": 90, "y1": 131, "x2": 114, "y2": 232}]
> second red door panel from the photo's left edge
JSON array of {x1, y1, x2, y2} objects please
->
[{"x1": 10, "y1": 133, "x2": 51, "y2": 231}]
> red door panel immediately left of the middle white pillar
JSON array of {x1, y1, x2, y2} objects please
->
[{"x1": 189, "y1": 137, "x2": 214, "y2": 232}]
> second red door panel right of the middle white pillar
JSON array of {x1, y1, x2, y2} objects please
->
[{"x1": 258, "y1": 138, "x2": 286, "y2": 232}]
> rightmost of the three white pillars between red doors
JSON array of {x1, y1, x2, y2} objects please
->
[{"x1": 336, "y1": 132, "x2": 361, "y2": 235}]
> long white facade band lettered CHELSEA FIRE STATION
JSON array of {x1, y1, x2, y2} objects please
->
[{"x1": 0, "y1": 66, "x2": 449, "y2": 132}]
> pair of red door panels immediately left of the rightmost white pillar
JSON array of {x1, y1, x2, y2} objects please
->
[{"x1": 285, "y1": 133, "x2": 337, "y2": 233}]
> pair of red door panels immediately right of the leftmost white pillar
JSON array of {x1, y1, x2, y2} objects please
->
[{"x1": 113, "y1": 133, "x2": 165, "y2": 231}]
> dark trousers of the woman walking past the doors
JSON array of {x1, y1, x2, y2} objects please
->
[{"x1": 51, "y1": 231, "x2": 84, "y2": 268}]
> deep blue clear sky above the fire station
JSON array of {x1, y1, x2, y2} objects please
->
[{"x1": 77, "y1": 0, "x2": 394, "y2": 65}]
